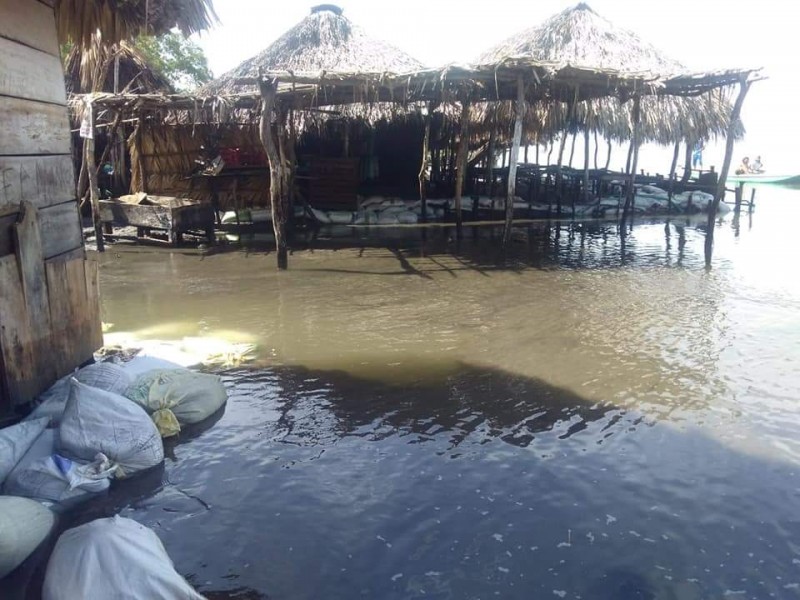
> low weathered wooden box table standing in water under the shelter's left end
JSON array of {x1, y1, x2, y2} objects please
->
[{"x1": 100, "y1": 195, "x2": 214, "y2": 244}]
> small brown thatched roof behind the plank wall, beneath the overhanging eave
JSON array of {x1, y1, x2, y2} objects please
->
[{"x1": 64, "y1": 40, "x2": 175, "y2": 94}]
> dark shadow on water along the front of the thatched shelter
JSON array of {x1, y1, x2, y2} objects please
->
[{"x1": 195, "y1": 215, "x2": 720, "y2": 279}]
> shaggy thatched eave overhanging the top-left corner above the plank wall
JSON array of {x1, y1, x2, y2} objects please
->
[{"x1": 55, "y1": 0, "x2": 217, "y2": 47}]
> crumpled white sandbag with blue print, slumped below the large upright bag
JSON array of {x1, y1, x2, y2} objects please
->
[{"x1": 3, "y1": 429, "x2": 115, "y2": 510}]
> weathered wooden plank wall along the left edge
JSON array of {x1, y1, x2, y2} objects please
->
[{"x1": 0, "y1": 0, "x2": 102, "y2": 418}]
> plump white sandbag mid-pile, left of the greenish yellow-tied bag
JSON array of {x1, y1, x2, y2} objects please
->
[{"x1": 56, "y1": 379, "x2": 164, "y2": 477}]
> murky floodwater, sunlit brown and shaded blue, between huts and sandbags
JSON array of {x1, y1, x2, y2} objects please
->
[{"x1": 6, "y1": 188, "x2": 800, "y2": 599}]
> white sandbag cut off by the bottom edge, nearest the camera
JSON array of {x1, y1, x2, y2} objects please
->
[{"x1": 42, "y1": 516, "x2": 203, "y2": 600}]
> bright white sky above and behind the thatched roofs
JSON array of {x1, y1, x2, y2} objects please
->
[{"x1": 196, "y1": 0, "x2": 800, "y2": 173}]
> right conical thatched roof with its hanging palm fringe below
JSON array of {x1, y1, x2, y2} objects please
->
[{"x1": 475, "y1": 3, "x2": 743, "y2": 144}]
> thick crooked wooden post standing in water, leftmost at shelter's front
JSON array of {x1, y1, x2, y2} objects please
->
[{"x1": 259, "y1": 79, "x2": 289, "y2": 269}]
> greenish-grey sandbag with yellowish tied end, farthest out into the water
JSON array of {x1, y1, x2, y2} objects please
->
[{"x1": 126, "y1": 369, "x2": 228, "y2": 437}]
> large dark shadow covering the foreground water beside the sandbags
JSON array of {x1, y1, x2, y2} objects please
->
[{"x1": 4, "y1": 363, "x2": 800, "y2": 600}]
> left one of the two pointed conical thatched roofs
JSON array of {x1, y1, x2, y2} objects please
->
[{"x1": 200, "y1": 4, "x2": 423, "y2": 95}]
